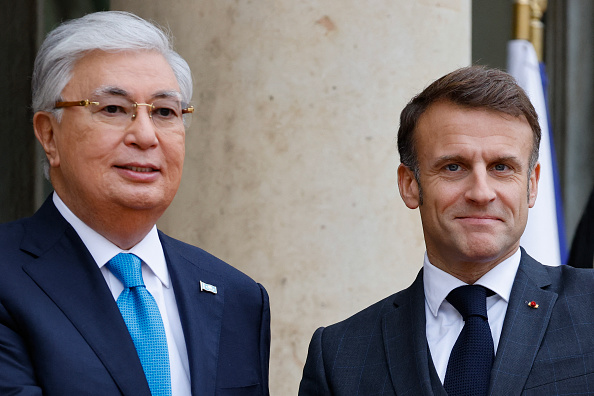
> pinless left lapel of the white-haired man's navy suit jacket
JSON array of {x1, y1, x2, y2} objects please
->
[{"x1": 21, "y1": 196, "x2": 150, "y2": 395}]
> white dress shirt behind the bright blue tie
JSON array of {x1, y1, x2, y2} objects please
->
[{"x1": 53, "y1": 192, "x2": 191, "y2": 396}]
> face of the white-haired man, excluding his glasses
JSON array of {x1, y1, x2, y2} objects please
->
[{"x1": 34, "y1": 51, "x2": 185, "y2": 226}]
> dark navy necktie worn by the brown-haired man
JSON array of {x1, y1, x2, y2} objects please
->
[{"x1": 443, "y1": 285, "x2": 495, "y2": 396}]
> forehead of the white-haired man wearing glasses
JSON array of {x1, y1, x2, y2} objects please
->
[{"x1": 62, "y1": 51, "x2": 180, "y2": 100}]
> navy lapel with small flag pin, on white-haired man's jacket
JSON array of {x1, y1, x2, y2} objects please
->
[{"x1": 159, "y1": 232, "x2": 225, "y2": 395}]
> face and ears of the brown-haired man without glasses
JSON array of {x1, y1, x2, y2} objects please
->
[{"x1": 398, "y1": 102, "x2": 540, "y2": 280}]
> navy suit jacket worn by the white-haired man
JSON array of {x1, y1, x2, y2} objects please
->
[{"x1": 0, "y1": 197, "x2": 270, "y2": 396}]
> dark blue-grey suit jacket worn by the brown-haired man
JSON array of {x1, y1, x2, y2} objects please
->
[{"x1": 299, "y1": 250, "x2": 594, "y2": 396}]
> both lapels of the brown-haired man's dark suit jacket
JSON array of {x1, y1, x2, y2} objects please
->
[{"x1": 382, "y1": 249, "x2": 558, "y2": 396}]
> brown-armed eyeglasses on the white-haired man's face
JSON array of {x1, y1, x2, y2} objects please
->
[{"x1": 55, "y1": 95, "x2": 194, "y2": 130}]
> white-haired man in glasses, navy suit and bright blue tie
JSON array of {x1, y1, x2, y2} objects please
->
[{"x1": 0, "y1": 12, "x2": 270, "y2": 396}]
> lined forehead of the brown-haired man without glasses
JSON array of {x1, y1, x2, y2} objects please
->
[{"x1": 415, "y1": 101, "x2": 534, "y2": 161}]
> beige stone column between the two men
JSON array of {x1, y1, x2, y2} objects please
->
[{"x1": 111, "y1": 0, "x2": 471, "y2": 395}]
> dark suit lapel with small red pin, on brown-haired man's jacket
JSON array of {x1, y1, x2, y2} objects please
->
[{"x1": 490, "y1": 249, "x2": 557, "y2": 395}]
